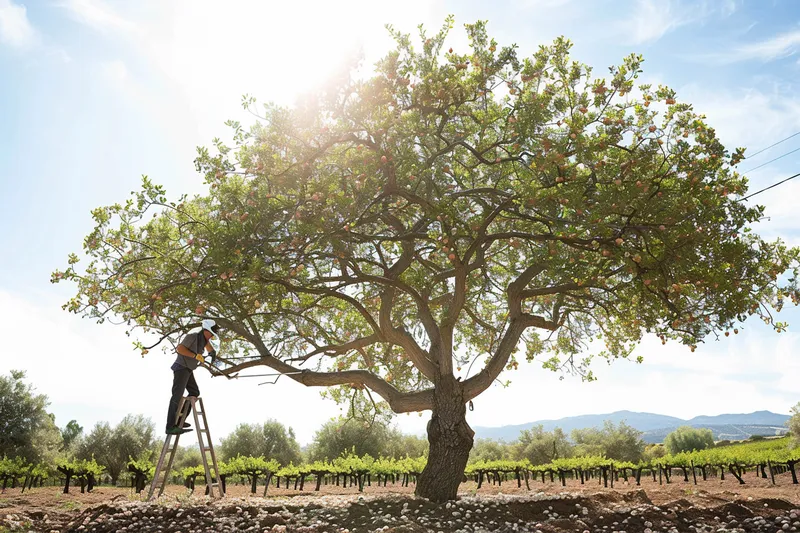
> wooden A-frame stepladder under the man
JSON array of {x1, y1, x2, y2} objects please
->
[{"x1": 147, "y1": 396, "x2": 225, "y2": 501}]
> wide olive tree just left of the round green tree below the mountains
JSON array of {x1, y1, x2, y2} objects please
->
[{"x1": 572, "y1": 420, "x2": 645, "y2": 463}]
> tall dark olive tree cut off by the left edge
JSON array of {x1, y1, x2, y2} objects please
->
[{"x1": 0, "y1": 370, "x2": 61, "y2": 463}]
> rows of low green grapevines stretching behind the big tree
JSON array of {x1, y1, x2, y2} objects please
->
[{"x1": 0, "y1": 438, "x2": 800, "y2": 496}]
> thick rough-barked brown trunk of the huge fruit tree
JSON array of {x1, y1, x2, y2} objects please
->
[{"x1": 414, "y1": 376, "x2": 475, "y2": 502}]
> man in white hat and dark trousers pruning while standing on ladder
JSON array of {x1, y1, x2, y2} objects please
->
[{"x1": 167, "y1": 319, "x2": 219, "y2": 435}]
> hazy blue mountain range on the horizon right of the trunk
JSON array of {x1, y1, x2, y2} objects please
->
[{"x1": 473, "y1": 411, "x2": 789, "y2": 443}]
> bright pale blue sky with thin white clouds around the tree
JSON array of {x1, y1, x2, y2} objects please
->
[{"x1": 0, "y1": 0, "x2": 800, "y2": 444}]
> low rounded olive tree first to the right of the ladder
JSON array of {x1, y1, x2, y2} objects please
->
[{"x1": 219, "y1": 420, "x2": 302, "y2": 465}]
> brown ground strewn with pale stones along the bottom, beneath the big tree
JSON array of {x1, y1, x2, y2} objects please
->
[{"x1": 0, "y1": 478, "x2": 800, "y2": 533}]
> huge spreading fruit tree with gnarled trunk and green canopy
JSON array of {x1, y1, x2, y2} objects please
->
[{"x1": 57, "y1": 19, "x2": 798, "y2": 501}]
